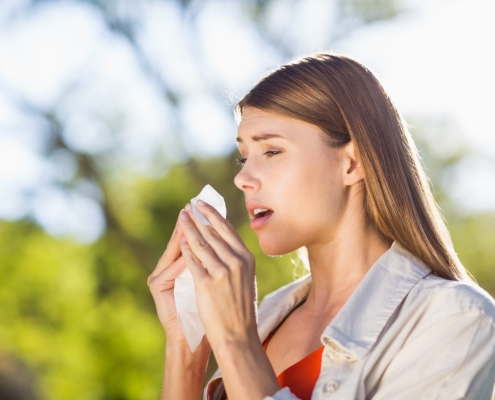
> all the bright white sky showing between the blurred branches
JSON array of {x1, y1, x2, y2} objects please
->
[{"x1": 0, "y1": 0, "x2": 495, "y2": 241}]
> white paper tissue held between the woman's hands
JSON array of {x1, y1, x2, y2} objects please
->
[{"x1": 174, "y1": 185, "x2": 227, "y2": 351}]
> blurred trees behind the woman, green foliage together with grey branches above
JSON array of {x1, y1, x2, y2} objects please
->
[{"x1": 0, "y1": 0, "x2": 495, "y2": 400}]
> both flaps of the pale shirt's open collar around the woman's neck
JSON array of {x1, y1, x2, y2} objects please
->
[{"x1": 258, "y1": 242, "x2": 431, "y2": 361}]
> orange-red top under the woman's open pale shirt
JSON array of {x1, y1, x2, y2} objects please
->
[{"x1": 226, "y1": 331, "x2": 324, "y2": 400}]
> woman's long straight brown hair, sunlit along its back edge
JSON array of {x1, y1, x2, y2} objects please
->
[{"x1": 236, "y1": 54, "x2": 470, "y2": 280}]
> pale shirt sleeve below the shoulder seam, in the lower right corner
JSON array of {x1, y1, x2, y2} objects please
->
[{"x1": 373, "y1": 310, "x2": 495, "y2": 400}]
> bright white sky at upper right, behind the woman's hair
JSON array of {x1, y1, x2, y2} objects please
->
[{"x1": 341, "y1": 0, "x2": 495, "y2": 213}]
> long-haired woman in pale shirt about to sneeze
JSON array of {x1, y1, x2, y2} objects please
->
[{"x1": 148, "y1": 54, "x2": 495, "y2": 400}]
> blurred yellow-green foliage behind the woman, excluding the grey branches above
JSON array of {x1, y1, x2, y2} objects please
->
[{"x1": 0, "y1": 154, "x2": 495, "y2": 400}]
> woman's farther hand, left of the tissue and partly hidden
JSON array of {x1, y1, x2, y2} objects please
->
[{"x1": 148, "y1": 216, "x2": 190, "y2": 343}]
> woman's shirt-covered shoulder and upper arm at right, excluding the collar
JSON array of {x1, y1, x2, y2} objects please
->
[{"x1": 369, "y1": 280, "x2": 495, "y2": 400}]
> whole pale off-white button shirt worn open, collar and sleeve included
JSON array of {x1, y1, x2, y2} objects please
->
[{"x1": 205, "y1": 243, "x2": 495, "y2": 400}]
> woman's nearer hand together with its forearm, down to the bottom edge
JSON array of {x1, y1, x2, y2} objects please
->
[{"x1": 179, "y1": 201, "x2": 280, "y2": 400}]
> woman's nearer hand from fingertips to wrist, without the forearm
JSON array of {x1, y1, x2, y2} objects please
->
[{"x1": 179, "y1": 201, "x2": 259, "y2": 351}]
